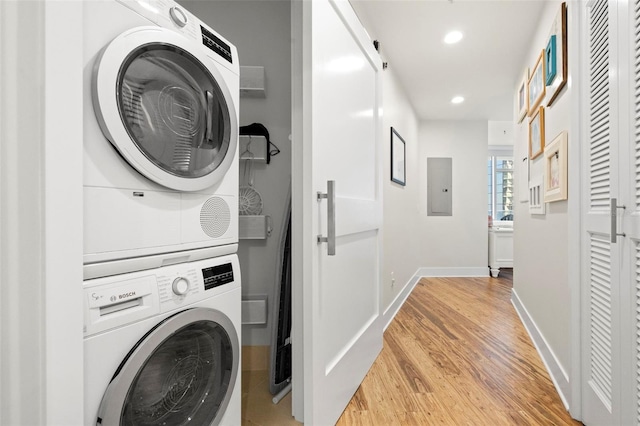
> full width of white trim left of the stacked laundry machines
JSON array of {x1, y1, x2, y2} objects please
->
[{"x1": 0, "y1": 2, "x2": 83, "y2": 425}]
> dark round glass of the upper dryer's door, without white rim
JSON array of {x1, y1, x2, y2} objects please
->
[{"x1": 117, "y1": 44, "x2": 231, "y2": 178}]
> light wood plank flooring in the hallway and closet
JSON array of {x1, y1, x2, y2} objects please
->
[{"x1": 242, "y1": 270, "x2": 581, "y2": 426}]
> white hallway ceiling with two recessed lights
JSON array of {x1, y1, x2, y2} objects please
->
[{"x1": 351, "y1": 0, "x2": 546, "y2": 120}]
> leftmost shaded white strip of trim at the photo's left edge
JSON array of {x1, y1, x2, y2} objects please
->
[{"x1": 0, "y1": 2, "x2": 47, "y2": 424}]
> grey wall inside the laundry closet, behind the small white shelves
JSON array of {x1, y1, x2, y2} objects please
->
[{"x1": 180, "y1": 0, "x2": 291, "y2": 345}]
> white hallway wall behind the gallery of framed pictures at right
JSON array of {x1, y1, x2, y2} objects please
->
[{"x1": 514, "y1": 1, "x2": 577, "y2": 402}]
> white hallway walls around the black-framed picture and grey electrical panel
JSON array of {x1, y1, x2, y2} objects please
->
[{"x1": 360, "y1": 10, "x2": 484, "y2": 322}]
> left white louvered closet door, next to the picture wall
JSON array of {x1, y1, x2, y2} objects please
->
[{"x1": 581, "y1": 0, "x2": 621, "y2": 425}]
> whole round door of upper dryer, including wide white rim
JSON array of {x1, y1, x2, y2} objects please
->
[{"x1": 93, "y1": 27, "x2": 238, "y2": 191}]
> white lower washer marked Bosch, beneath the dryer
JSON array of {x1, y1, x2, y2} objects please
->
[{"x1": 84, "y1": 255, "x2": 241, "y2": 426}]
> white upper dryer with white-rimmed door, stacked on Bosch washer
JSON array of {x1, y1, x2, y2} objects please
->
[{"x1": 83, "y1": 0, "x2": 239, "y2": 279}]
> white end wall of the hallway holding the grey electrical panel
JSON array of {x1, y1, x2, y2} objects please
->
[{"x1": 420, "y1": 121, "x2": 489, "y2": 276}]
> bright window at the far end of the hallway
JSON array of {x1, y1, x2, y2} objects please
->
[{"x1": 487, "y1": 156, "x2": 513, "y2": 221}]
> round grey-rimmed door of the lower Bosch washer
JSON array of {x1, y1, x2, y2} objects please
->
[{"x1": 97, "y1": 308, "x2": 239, "y2": 426}]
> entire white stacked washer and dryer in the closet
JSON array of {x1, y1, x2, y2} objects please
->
[{"x1": 83, "y1": 0, "x2": 241, "y2": 425}]
